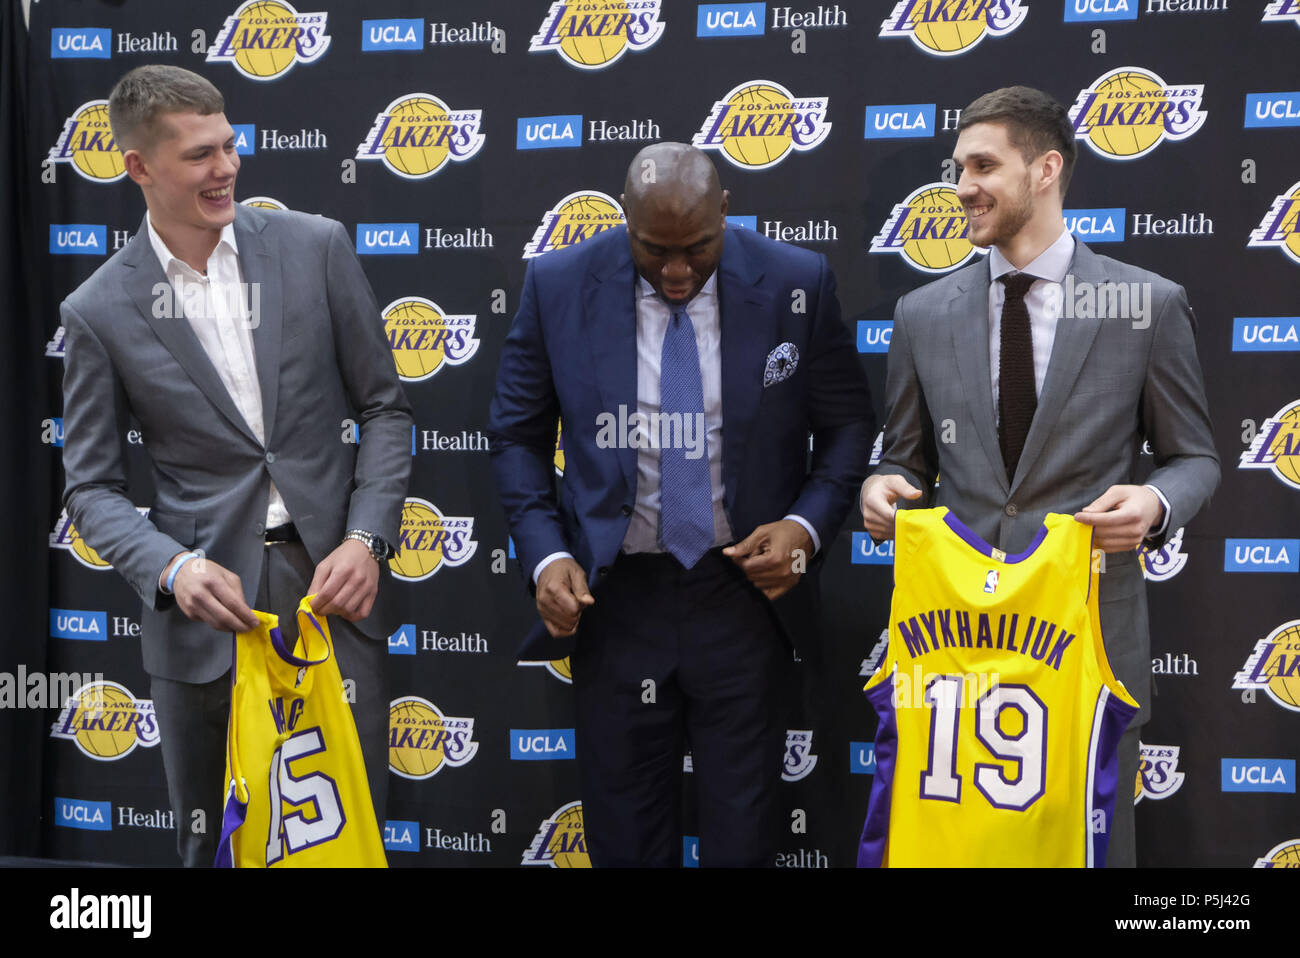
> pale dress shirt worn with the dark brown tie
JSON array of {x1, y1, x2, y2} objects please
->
[{"x1": 988, "y1": 224, "x2": 1169, "y2": 536}]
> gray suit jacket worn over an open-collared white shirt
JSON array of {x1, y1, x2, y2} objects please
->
[{"x1": 61, "y1": 207, "x2": 412, "y2": 682}]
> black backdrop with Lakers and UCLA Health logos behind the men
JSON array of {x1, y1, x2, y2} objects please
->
[{"x1": 12, "y1": 0, "x2": 1300, "y2": 867}]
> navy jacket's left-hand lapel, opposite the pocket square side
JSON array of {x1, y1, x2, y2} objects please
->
[{"x1": 575, "y1": 240, "x2": 637, "y2": 494}]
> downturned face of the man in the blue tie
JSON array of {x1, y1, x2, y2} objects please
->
[{"x1": 624, "y1": 191, "x2": 727, "y2": 305}]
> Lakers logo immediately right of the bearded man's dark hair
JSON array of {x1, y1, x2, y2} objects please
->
[{"x1": 1070, "y1": 66, "x2": 1205, "y2": 160}]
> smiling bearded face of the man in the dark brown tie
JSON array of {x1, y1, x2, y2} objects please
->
[{"x1": 953, "y1": 123, "x2": 1034, "y2": 252}]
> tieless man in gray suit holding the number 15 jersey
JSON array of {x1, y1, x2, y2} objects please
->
[{"x1": 62, "y1": 66, "x2": 411, "y2": 866}]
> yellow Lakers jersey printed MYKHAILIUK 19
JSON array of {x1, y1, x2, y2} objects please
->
[{"x1": 858, "y1": 508, "x2": 1138, "y2": 867}]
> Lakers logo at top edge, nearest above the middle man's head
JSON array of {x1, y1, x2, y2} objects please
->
[{"x1": 528, "y1": 0, "x2": 664, "y2": 70}]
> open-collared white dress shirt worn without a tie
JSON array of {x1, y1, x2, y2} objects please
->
[{"x1": 144, "y1": 213, "x2": 289, "y2": 529}]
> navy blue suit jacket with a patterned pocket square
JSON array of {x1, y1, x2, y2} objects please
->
[{"x1": 488, "y1": 226, "x2": 875, "y2": 659}]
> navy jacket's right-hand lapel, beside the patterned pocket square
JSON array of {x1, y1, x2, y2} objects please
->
[{"x1": 718, "y1": 229, "x2": 769, "y2": 514}]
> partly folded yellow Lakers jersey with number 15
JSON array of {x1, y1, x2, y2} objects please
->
[{"x1": 216, "y1": 595, "x2": 386, "y2": 868}]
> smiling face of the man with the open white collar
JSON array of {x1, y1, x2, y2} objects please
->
[{"x1": 126, "y1": 113, "x2": 239, "y2": 257}]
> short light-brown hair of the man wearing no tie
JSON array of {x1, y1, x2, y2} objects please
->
[{"x1": 108, "y1": 64, "x2": 226, "y2": 151}]
